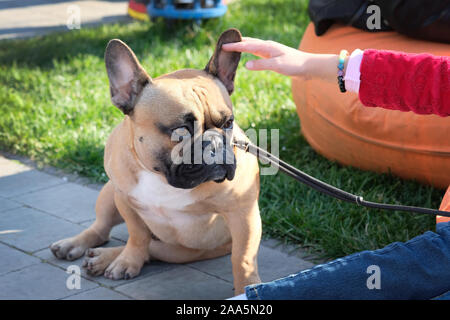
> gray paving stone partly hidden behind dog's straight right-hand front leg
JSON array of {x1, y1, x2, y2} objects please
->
[{"x1": 188, "y1": 245, "x2": 314, "y2": 282}]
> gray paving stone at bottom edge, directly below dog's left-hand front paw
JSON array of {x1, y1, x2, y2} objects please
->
[{"x1": 115, "y1": 265, "x2": 234, "y2": 300}]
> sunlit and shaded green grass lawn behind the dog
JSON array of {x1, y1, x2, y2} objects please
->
[{"x1": 0, "y1": 0, "x2": 443, "y2": 258}]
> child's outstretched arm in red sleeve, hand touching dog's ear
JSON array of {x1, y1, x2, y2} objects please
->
[{"x1": 223, "y1": 38, "x2": 450, "y2": 116}]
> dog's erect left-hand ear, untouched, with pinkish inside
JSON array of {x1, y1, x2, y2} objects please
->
[{"x1": 105, "y1": 39, "x2": 151, "y2": 114}]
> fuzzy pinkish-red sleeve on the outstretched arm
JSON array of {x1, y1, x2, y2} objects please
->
[{"x1": 359, "y1": 49, "x2": 450, "y2": 116}]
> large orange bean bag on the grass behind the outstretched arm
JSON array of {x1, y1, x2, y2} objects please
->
[{"x1": 292, "y1": 24, "x2": 450, "y2": 188}]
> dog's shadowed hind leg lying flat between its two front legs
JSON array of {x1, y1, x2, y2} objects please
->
[{"x1": 149, "y1": 240, "x2": 231, "y2": 263}]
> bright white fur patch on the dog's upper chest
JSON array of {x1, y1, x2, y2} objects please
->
[{"x1": 130, "y1": 171, "x2": 194, "y2": 210}]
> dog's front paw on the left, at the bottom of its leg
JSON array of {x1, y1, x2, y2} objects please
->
[{"x1": 105, "y1": 250, "x2": 145, "y2": 280}]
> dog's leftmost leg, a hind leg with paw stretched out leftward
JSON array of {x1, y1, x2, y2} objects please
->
[{"x1": 50, "y1": 182, "x2": 123, "y2": 260}]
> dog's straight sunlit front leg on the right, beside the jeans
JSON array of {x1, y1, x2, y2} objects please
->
[{"x1": 226, "y1": 201, "x2": 262, "y2": 295}]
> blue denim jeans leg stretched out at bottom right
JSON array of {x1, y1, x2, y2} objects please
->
[{"x1": 245, "y1": 222, "x2": 450, "y2": 300}]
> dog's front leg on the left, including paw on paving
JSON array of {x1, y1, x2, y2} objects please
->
[{"x1": 105, "y1": 193, "x2": 151, "y2": 280}]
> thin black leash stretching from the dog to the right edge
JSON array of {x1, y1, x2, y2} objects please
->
[{"x1": 233, "y1": 141, "x2": 450, "y2": 217}]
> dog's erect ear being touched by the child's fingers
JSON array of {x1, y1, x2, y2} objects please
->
[{"x1": 205, "y1": 29, "x2": 242, "y2": 94}]
